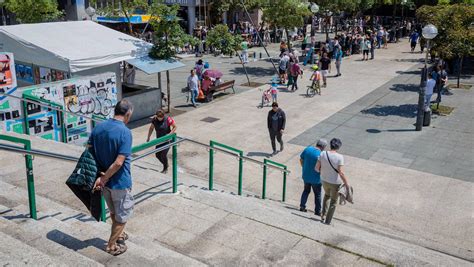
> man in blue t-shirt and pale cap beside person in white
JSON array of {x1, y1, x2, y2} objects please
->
[{"x1": 300, "y1": 139, "x2": 328, "y2": 216}]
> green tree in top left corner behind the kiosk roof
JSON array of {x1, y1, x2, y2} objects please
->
[{"x1": 0, "y1": 0, "x2": 64, "y2": 23}]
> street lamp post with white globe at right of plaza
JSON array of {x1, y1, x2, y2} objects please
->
[{"x1": 416, "y1": 24, "x2": 438, "y2": 131}]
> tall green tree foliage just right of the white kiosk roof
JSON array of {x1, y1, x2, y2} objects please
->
[{"x1": 150, "y1": 3, "x2": 197, "y2": 59}]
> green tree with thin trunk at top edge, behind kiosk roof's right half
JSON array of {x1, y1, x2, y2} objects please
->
[{"x1": 90, "y1": 0, "x2": 148, "y2": 34}]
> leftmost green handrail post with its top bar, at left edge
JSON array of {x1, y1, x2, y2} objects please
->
[{"x1": 0, "y1": 134, "x2": 38, "y2": 220}]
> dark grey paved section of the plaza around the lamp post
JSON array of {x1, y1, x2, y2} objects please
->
[{"x1": 290, "y1": 63, "x2": 474, "y2": 182}]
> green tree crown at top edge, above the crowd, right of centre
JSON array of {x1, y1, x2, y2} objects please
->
[{"x1": 263, "y1": 0, "x2": 311, "y2": 29}]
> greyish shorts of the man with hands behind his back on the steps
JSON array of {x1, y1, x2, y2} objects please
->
[{"x1": 103, "y1": 187, "x2": 134, "y2": 223}]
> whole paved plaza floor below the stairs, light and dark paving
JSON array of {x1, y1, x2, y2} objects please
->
[{"x1": 133, "y1": 38, "x2": 474, "y2": 259}]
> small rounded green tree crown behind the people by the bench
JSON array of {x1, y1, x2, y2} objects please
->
[{"x1": 206, "y1": 24, "x2": 243, "y2": 56}]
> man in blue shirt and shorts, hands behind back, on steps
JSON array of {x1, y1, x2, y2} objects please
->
[{"x1": 89, "y1": 99, "x2": 134, "y2": 256}]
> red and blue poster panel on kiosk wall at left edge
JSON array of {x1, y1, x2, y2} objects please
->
[{"x1": 0, "y1": 52, "x2": 23, "y2": 133}]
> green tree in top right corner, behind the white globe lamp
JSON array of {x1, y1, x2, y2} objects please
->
[{"x1": 416, "y1": 4, "x2": 474, "y2": 87}]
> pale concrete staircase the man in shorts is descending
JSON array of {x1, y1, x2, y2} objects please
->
[{"x1": 0, "y1": 133, "x2": 472, "y2": 266}]
